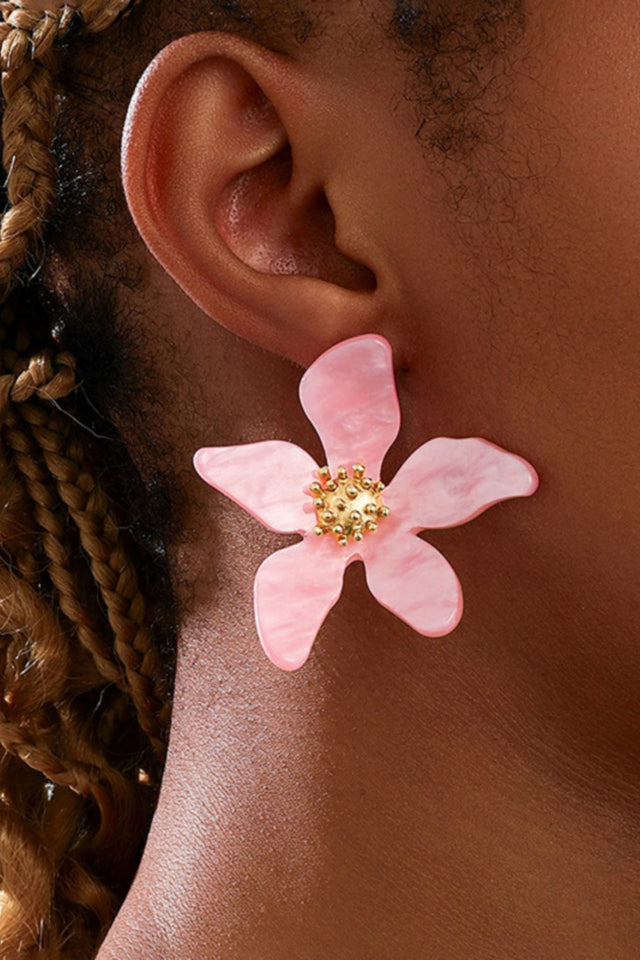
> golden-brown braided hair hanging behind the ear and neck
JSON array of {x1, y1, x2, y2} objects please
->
[{"x1": 0, "y1": 0, "x2": 170, "y2": 960}]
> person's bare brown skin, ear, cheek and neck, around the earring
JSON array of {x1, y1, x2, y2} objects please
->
[{"x1": 87, "y1": 0, "x2": 640, "y2": 960}]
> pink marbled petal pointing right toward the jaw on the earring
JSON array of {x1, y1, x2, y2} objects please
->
[{"x1": 384, "y1": 437, "x2": 538, "y2": 531}]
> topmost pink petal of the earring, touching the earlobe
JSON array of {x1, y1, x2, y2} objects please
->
[{"x1": 300, "y1": 334, "x2": 400, "y2": 480}]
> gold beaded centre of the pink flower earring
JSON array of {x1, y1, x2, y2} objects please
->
[{"x1": 310, "y1": 463, "x2": 389, "y2": 547}]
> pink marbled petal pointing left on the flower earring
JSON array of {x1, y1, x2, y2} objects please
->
[{"x1": 193, "y1": 440, "x2": 318, "y2": 533}]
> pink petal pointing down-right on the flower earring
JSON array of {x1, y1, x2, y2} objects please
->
[{"x1": 364, "y1": 518, "x2": 462, "y2": 637}]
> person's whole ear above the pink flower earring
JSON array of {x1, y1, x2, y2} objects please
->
[{"x1": 122, "y1": 33, "x2": 379, "y2": 363}]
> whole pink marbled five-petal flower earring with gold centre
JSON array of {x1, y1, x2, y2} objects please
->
[{"x1": 194, "y1": 334, "x2": 538, "y2": 670}]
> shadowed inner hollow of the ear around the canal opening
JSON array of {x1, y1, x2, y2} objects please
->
[{"x1": 214, "y1": 143, "x2": 376, "y2": 291}]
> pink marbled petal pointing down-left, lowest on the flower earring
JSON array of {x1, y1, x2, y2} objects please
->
[{"x1": 253, "y1": 537, "x2": 346, "y2": 670}]
